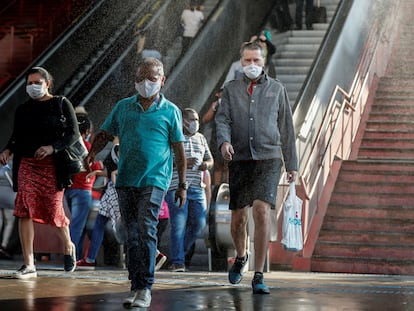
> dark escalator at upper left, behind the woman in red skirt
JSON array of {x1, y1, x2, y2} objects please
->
[{"x1": 0, "y1": 0, "x2": 186, "y2": 146}]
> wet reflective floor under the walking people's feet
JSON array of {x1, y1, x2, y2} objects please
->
[{"x1": 0, "y1": 262, "x2": 414, "y2": 311}]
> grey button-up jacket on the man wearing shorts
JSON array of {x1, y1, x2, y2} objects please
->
[{"x1": 215, "y1": 74, "x2": 298, "y2": 171}]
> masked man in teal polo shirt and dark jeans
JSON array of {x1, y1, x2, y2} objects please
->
[{"x1": 86, "y1": 58, "x2": 187, "y2": 308}]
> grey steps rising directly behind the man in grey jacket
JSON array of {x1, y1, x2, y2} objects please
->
[{"x1": 272, "y1": 0, "x2": 340, "y2": 105}]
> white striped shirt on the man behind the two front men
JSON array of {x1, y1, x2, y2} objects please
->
[{"x1": 169, "y1": 132, "x2": 213, "y2": 190}]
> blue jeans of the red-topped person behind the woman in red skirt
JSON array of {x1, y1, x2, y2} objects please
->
[{"x1": 65, "y1": 188, "x2": 92, "y2": 259}]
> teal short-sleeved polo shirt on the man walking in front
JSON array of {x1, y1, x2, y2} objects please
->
[{"x1": 101, "y1": 94, "x2": 185, "y2": 191}]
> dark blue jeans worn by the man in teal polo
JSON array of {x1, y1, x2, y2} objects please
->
[{"x1": 117, "y1": 187, "x2": 165, "y2": 291}]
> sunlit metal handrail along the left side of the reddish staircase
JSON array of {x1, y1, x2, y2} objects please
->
[{"x1": 300, "y1": 18, "x2": 384, "y2": 243}]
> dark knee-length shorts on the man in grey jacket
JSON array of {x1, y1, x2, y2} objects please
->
[{"x1": 229, "y1": 159, "x2": 283, "y2": 210}]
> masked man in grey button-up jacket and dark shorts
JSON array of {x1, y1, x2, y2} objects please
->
[{"x1": 215, "y1": 42, "x2": 298, "y2": 294}]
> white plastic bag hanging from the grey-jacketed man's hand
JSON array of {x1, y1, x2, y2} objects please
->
[{"x1": 282, "y1": 182, "x2": 303, "y2": 252}]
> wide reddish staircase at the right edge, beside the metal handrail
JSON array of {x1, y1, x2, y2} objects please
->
[{"x1": 311, "y1": 2, "x2": 414, "y2": 275}]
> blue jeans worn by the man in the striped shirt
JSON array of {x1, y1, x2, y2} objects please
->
[{"x1": 165, "y1": 187, "x2": 207, "y2": 265}]
